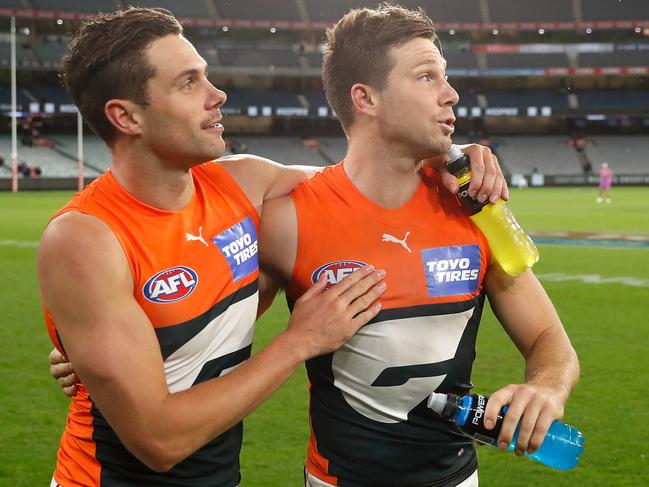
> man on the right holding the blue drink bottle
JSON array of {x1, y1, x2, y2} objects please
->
[{"x1": 260, "y1": 4, "x2": 579, "y2": 487}]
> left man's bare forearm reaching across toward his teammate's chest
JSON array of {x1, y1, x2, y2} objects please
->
[{"x1": 120, "y1": 332, "x2": 303, "y2": 471}]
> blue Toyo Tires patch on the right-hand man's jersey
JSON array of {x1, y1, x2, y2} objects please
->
[{"x1": 421, "y1": 245, "x2": 480, "y2": 298}]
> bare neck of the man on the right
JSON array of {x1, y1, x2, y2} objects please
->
[{"x1": 344, "y1": 127, "x2": 421, "y2": 208}]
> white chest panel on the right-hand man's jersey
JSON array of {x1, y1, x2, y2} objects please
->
[{"x1": 332, "y1": 308, "x2": 474, "y2": 423}]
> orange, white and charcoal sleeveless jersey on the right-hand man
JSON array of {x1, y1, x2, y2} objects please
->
[{"x1": 287, "y1": 163, "x2": 490, "y2": 487}]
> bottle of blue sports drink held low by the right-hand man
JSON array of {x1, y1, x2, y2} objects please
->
[{"x1": 428, "y1": 392, "x2": 584, "y2": 470}]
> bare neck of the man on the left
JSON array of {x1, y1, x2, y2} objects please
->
[{"x1": 111, "y1": 140, "x2": 194, "y2": 211}]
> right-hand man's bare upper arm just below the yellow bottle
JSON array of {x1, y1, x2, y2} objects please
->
[{"x1": 485, "y1": 264, "x2": 563, "y2": 357}]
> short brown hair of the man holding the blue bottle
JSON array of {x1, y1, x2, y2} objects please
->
[{"x1": 322, "y1": 3, "x2": 437, "y2": 132}]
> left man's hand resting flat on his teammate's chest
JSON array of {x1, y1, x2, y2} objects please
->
[{"x1": 285, "y1": 265, "x2": 386, "y2": 360}]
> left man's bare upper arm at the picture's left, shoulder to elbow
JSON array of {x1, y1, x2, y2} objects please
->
[{"x1": 39, "y1": 217, "x2": 168, "y2": 445}]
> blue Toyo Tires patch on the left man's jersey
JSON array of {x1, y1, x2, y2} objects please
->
[{"x1": 212, "y1": 217, "x2": 259, "y2": 281}]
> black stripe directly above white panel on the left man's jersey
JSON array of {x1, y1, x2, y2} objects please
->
[{"x1": 155, "y1": 279, "x2": 259, "y2": 360}]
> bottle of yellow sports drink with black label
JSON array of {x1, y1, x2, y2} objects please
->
[{"x1": 446, "y1": 145, "x2": 539, "y2": 276}]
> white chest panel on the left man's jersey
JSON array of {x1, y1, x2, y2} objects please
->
[{"x1": 164, "y1": 293, "x2": 259, "y2": 393}]
